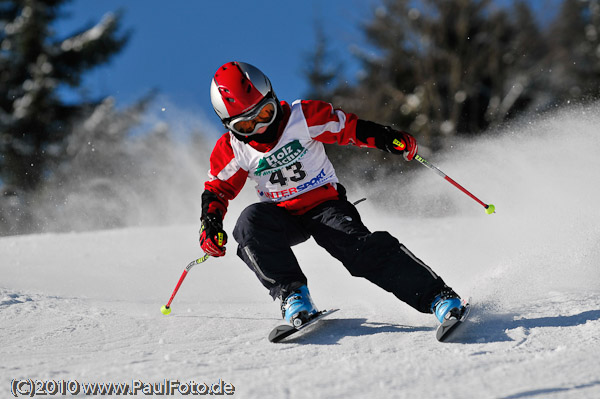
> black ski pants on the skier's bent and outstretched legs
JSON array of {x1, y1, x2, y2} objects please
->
[{"x1": 233, "y1": 200, "x2": 447, "y2": 313}]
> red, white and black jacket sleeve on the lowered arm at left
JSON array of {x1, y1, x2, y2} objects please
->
[{"x1": 202, "y1": 133, "x2": 248, "y2": 218}]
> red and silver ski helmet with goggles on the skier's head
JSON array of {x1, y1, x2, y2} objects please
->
[{"x1": 210, "y1": 62, "x2": 278, "y2": 136}]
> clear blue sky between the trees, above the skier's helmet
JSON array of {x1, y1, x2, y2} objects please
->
[{"x1": 55, "y1": 0, "x2": 370, "y2": 124}]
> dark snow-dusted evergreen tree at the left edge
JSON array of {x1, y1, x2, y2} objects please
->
[{"x1": 0, "y1": 0, "x2": 128, "y2": 193}]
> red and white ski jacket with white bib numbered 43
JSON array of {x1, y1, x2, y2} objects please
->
[{"x1": 203, "y1": 100, "x2": 382, "y2": 216}]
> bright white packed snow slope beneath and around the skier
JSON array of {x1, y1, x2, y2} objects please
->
[{"x1": 0, "y1": 106, "x2": 600, "y2": 399}]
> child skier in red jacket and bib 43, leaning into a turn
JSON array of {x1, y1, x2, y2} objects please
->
[{"x1": 200, "y1": 62, "x2": 464, "y2": 326}]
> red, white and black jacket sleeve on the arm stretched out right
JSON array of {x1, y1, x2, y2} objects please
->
[{"x1": 302, "y1": 100, "x2": 412, "y2": 152}]
